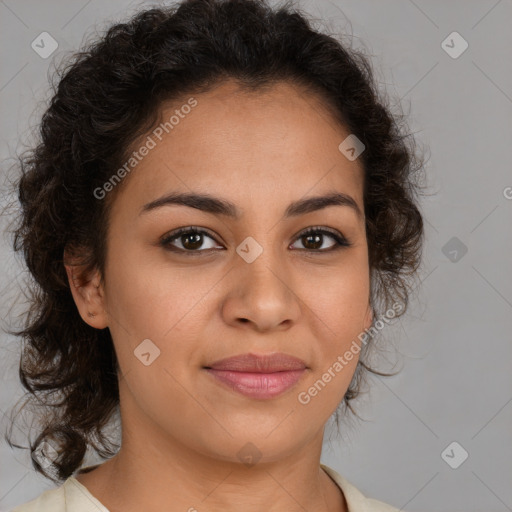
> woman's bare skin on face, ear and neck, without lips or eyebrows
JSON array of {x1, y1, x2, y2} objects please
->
[{"x1": 66, "y1": 81, "x2": 372, "y2": 512}]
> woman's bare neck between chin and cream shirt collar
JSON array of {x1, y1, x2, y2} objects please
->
[{"x1": 76, "y1": 382, "x2": 348, "y2": 512}]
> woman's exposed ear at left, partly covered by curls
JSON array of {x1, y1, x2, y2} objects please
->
[{"x1": 64, "y1": 251, "x2": 108, "y2": 329}]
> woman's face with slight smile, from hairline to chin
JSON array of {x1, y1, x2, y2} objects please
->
[{"x1": 70, "y1": 82, "x2": 371, "y2": 461}]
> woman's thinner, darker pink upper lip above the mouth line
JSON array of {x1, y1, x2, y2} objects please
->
[{"x1": 205, "y1": 352, "x2": 306, "y2": 373}]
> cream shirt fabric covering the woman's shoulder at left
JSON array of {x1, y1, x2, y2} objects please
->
[{"x1": 10, "y1": 476, "x2": 108, "y2": 512}]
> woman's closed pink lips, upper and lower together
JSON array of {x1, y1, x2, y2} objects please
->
[{"x1": 204, "y1": 353, "x2": 307, "y2": 400}]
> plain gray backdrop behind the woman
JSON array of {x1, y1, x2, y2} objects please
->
[{"x1": 0, "y1": 0, "x2": 512, "y2": 512}]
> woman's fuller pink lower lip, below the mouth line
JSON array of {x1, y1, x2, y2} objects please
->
[{"x1": 207, "y1": 368, "x2": 306, "y2": 399}]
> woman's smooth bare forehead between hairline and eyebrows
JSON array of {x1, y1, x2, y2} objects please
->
[{"x1": 109, "y1": 80, "x2": 363, "y2": 222}]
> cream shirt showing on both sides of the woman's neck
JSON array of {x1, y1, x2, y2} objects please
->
[{"x1": 11, "y1": 464, "x2": 399, "y2": 512}]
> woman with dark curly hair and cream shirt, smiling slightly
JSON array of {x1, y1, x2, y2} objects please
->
[{"x1": 7, "y1": 0, "x2": 423, "y2": 512}]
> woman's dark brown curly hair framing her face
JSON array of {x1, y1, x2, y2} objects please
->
[{"x1": 6, "y1": 0, "x2": 424, "y2": 482}]
